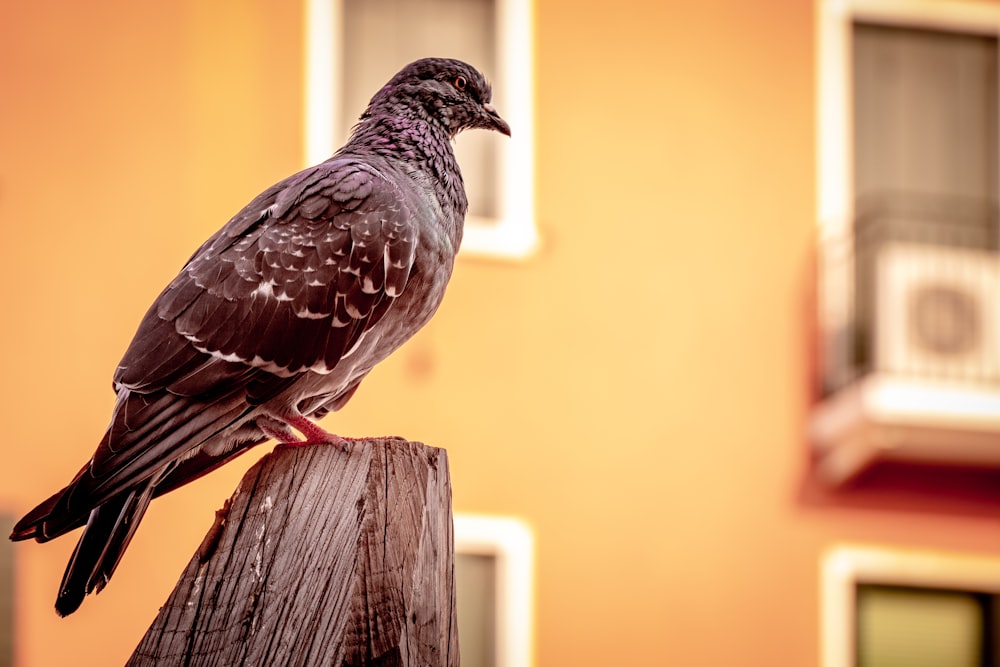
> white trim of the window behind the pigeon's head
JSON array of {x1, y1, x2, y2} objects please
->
[{"x1": 303, "y1": 0, "x2": 538, "y2": 259}]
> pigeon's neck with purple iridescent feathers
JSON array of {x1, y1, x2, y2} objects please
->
[{"x1": 342, "y1": 115, "x2": 468, "y2": 223}]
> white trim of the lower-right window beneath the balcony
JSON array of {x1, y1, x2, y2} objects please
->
[{"x1": 820, "y1": 545, "x2": 1000, "y2": 667}]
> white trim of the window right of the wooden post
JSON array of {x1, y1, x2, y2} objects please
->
[{"x1": 455, "y1": 514, "x2": 534, "y2": 667}]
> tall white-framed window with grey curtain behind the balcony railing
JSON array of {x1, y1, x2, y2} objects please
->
[{"x1": 817, "y1": 0, "x2": 1000, "y2": 391}]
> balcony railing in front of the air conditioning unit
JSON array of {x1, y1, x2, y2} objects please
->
[{"x1": 821, "y1": 190, "x2": 1000, "y2": 394}]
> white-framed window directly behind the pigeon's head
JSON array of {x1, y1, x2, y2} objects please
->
[{"x1": 305, "y1": 0, "x2": 537, "y2": 258}]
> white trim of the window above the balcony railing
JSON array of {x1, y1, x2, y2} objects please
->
[{"x1": 816, "y1": 0, "x2": 1000, "y2": 239}]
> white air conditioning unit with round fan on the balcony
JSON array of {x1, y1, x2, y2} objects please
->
[{"x1": 873, "y1": 243, "x2": 1000, "y2": 383}]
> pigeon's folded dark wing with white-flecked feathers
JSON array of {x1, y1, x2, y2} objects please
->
[{"x1": 115, "y1": 159, "x2": 417, "y2": 400}]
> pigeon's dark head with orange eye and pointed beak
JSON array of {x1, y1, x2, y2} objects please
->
[{"x1": 361, "y1": 58, "x2": 510, "y2": 137}]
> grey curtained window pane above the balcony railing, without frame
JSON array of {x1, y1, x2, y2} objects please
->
[{"x1": 851, "y1": 20, "x2": 998, "y2": 217}]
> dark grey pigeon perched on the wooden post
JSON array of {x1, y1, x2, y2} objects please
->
[{"x1": 10, "y1": 58, "x2": 510, "y2": 616}]
